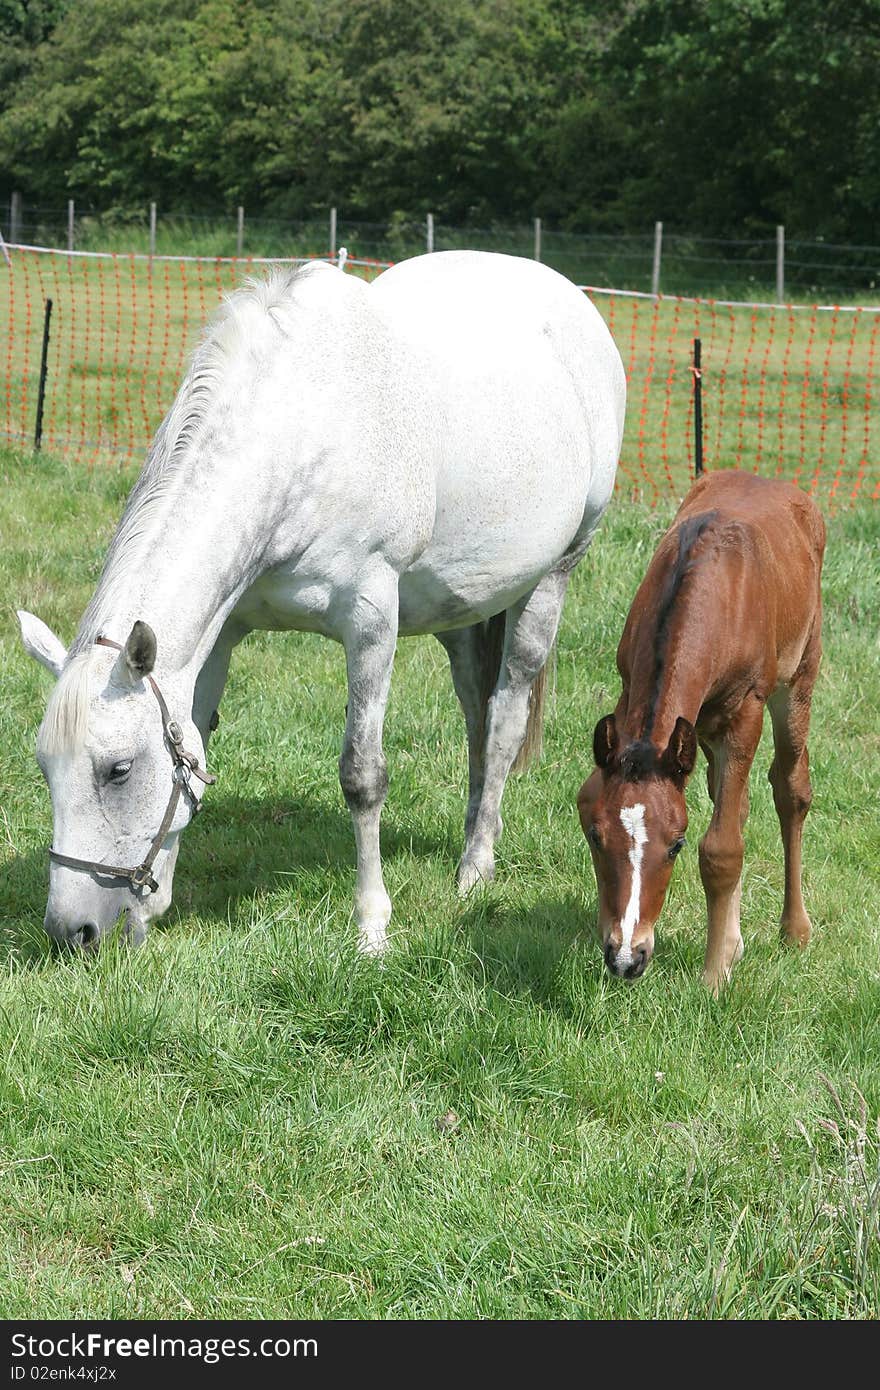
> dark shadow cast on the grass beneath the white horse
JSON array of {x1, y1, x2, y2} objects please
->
[{"x1": 0, "y1": 794, "x2": 455, "y2": 966}]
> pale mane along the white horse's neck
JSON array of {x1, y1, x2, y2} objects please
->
[{"x1": 68, "y1": 267, "x2": 311, "y2": 661}]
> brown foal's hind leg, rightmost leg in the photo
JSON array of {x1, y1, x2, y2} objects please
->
[{"x1": 767, "y1": 630, "x2": 822, "y2": 947}]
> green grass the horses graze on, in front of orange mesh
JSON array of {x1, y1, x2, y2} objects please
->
[{"x1": 0, "y1": 452, "x2": 880, "y2": 1318}]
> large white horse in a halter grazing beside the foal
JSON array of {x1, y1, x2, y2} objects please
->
[{"x1": 19, "y1": 252, "x2": 626, "y2": 952}]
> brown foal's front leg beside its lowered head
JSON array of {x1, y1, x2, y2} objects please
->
[{"x1": 699, "y1": 696, "x2": 763, "y2": 992}]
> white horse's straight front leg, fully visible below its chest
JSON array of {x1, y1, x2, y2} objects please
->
[{"x1": 339, "y1": 570, "x2": 398, "y2": 955}]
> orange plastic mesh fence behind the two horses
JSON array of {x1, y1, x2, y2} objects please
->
[{"x1": 0, "y1": 246, "x2": 880, "y2": 507}]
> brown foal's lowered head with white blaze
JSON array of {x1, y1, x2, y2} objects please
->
[{"x1": 577, "y1": 714, "x2": 696, "y2": 980}]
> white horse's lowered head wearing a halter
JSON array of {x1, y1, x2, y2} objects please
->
[{"x1": 19, "y1": 613, "x2": 204, "y2": 947}]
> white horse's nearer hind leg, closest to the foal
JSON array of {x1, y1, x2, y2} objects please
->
[{"x1": 459, "y1": 573, "x2": 569, "y2": 894}]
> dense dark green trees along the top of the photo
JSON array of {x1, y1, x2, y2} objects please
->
[{"x1": 0, "y1": 0, "x2": 880, "y2": 243}]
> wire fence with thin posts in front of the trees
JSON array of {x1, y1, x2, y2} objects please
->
[{"x1": 0, "y1": 199, "x2": 880, "y2": 303}]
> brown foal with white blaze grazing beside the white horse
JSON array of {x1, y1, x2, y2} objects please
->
[{"x1": 577, "y1": 471, "x2": 824, "y2": 991}]
